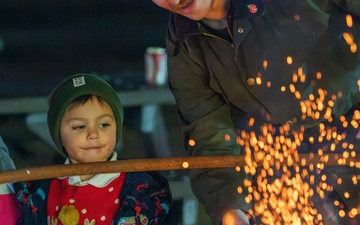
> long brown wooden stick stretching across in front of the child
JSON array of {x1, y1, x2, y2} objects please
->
[{"x1": 0, "y1": 154, "x2": 360, "y2": 184}]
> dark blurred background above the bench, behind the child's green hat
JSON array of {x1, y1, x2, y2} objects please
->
[{"x1": 0, "y1": 0, "x2": 169, "y2": 97}]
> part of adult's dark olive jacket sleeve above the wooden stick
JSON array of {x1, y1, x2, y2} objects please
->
[{"x1": 168, "y1": 35, "x2": 240, "y2": 156}]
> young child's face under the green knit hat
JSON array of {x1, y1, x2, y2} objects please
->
[{"x1": 60, "y1": 96, "x2": 116, "y2": 163}]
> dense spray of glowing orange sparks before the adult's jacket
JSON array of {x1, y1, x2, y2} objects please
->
[{"x1": 233, "y1": 61, "x2": 360, "y2": 225}]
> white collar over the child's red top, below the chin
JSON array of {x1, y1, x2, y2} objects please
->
[{"x1": 59, "y1": 152, "x2": 120, "y2": 188}]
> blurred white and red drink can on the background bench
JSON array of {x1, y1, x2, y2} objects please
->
[{"x1": 145, "y1": 47, "x2": 167, "y2": 86}]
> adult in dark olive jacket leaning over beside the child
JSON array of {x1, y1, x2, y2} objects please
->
[{"x1": 152, "y1": 0, "x2": 360, "y2": 225}]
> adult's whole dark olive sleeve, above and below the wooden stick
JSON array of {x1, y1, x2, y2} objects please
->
[{"x1": 167, "y1": 37, "x2": 249, "y2": 224}]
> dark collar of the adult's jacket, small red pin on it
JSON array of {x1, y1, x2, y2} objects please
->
[{"x1": 169, "y1": 0, "x2": 264, "y2": 42}]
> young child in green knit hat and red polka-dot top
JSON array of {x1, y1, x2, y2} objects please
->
[{"x1": 14, "y1": 74, "x2": 172, "y2": 225}]
